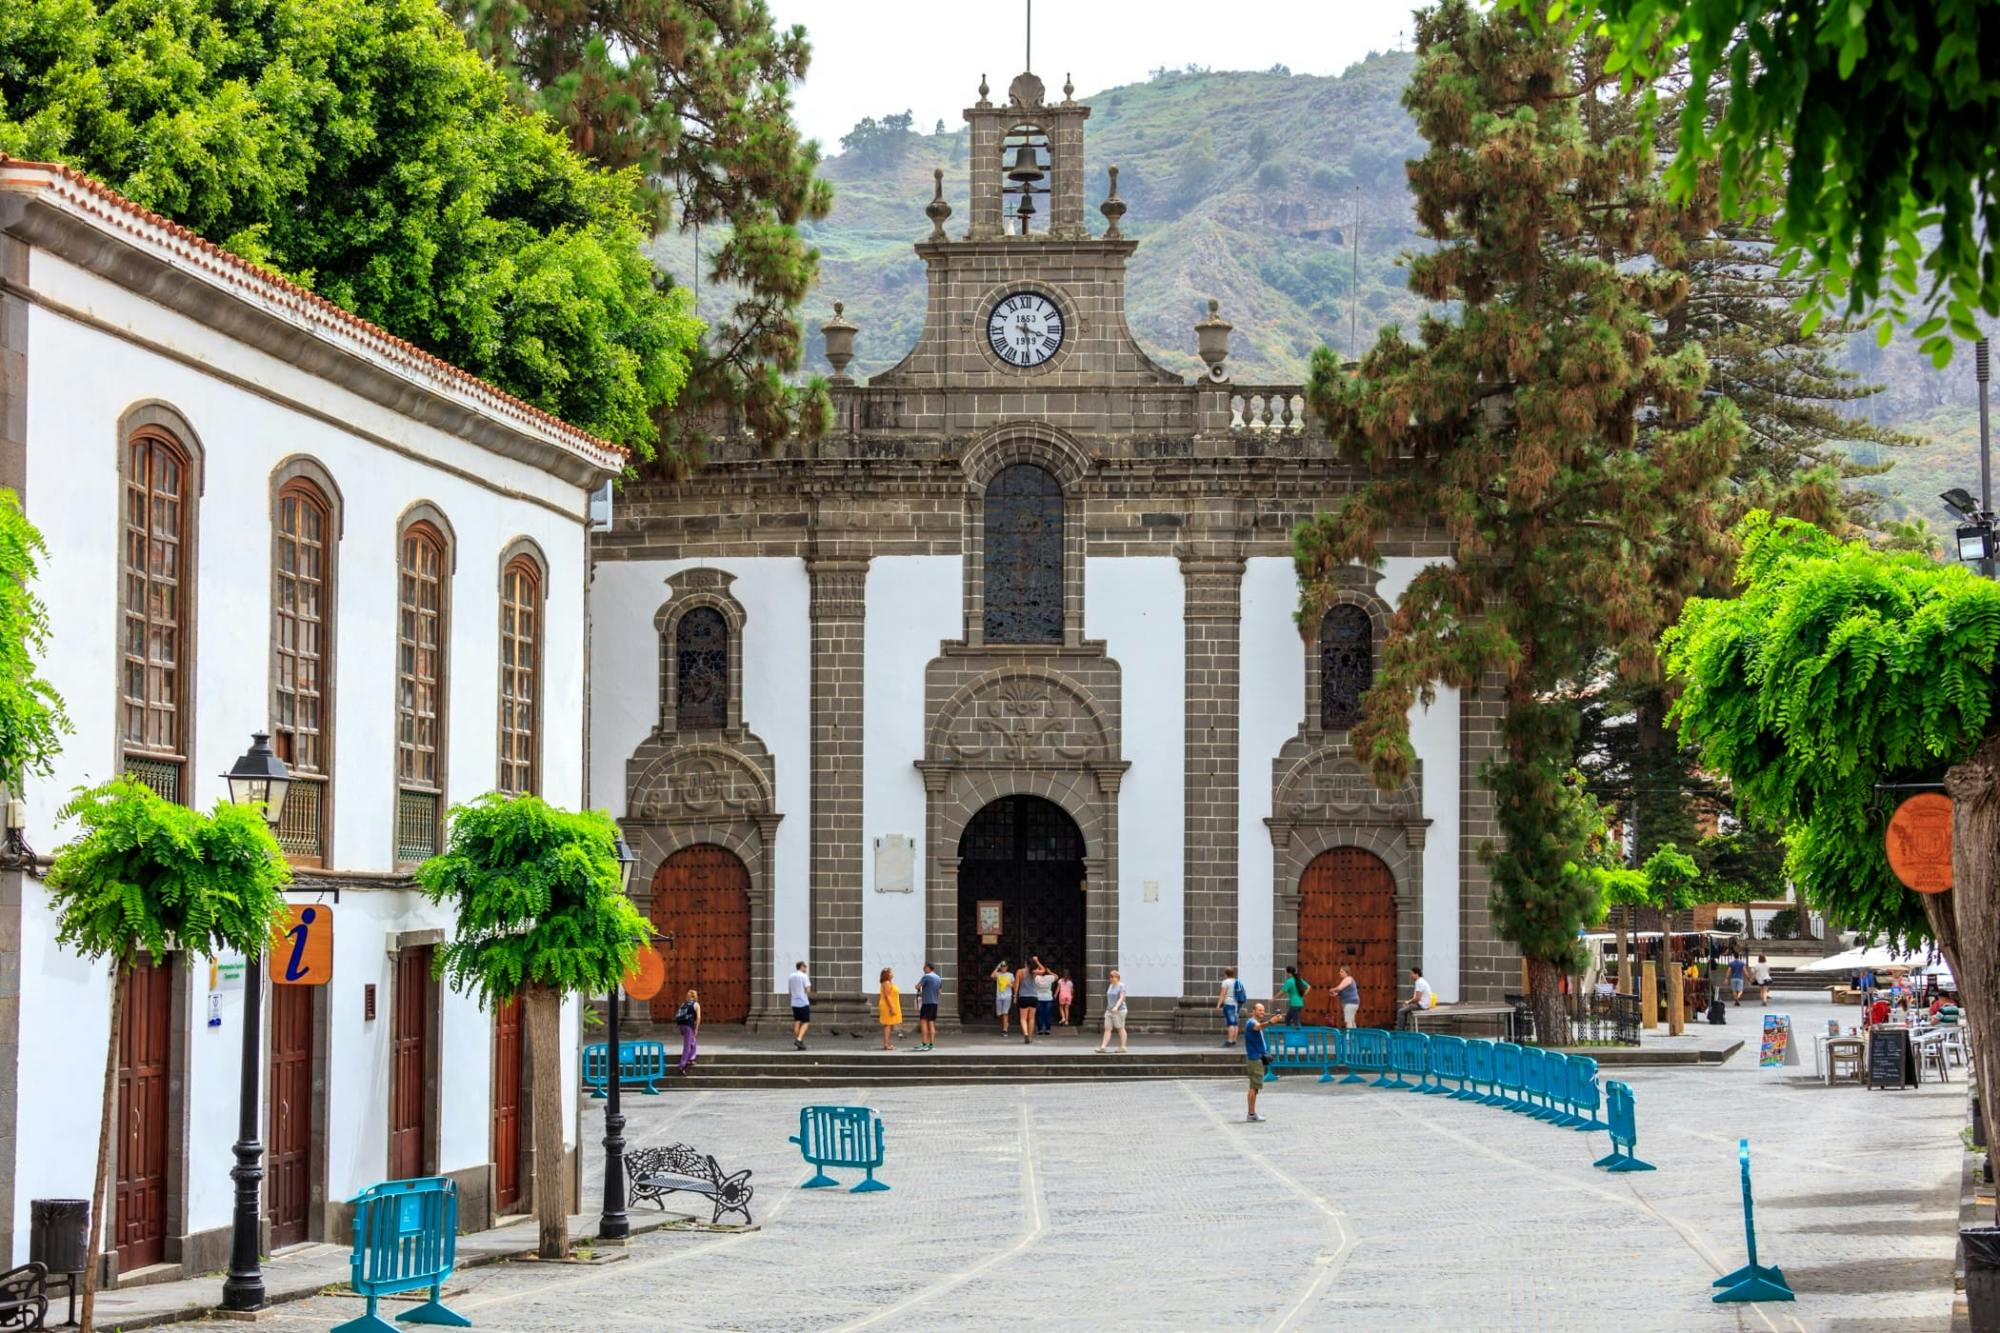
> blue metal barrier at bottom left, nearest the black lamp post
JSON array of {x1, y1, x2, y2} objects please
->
[{"x1": 332, "y1": 1175, "x2": 472, "y2": 1333}]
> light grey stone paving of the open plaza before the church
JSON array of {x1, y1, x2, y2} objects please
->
[{"x1": 164, "y1": 1005, "x2": 1966, "y2": 1331}]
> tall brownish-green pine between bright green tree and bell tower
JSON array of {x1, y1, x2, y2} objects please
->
[{"x1": 444, "y1": 0, "x2": 832, "y2": 462}]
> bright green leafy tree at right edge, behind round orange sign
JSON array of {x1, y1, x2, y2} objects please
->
[{"x1": 1662, "y1": 512, "x2": 2000, "y2": 1176}]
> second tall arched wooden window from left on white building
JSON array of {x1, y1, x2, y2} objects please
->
[{"x1": 270, "y1": 476, "x2": 334, "y2": 865}]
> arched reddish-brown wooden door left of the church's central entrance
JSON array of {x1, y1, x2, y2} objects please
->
[{"x1": 652, "y1": 843, "x2": 750, "y2": 1023}]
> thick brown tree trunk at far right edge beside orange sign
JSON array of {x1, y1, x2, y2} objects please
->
[{"x1": 1924, "y1": 737, "x2": 2000, "y2": 1219}]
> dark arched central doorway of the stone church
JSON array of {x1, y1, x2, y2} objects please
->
[{"x1": 958, "y1": 797, "x2": 1090, "y2": 1025}]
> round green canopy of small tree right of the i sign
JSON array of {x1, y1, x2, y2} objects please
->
[{"x1": 416, "y1": 793, "x2": 650, "y2": 1005}]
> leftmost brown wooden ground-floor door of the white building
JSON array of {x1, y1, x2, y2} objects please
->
[{"x1": 112, "y1": 963, "x2": 174, "y2": 1273}]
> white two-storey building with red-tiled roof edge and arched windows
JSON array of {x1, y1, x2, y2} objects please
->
[{"x1": 0, "y1": 158, "x2": 624, "y2": 1281}]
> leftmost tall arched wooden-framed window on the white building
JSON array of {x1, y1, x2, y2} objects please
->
[{"x1": 120, "y1": 426, "x2": 194, "y2": 801}]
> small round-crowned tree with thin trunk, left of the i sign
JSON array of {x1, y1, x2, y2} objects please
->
[{"x1": 46, "y1": 777, "x2": 292, "y2": 1329}]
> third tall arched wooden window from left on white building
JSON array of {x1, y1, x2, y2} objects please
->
[{"x1": 396, "y1": 520, "x2": 450, "y2": 863}]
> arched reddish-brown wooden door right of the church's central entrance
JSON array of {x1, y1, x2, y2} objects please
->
[{"x1": 1298, "y1": 847, "x2": 1396, "y2": 1027}]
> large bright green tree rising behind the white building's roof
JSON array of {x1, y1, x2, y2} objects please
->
[{"x1": 0, "y1": 0, "x2": 698, "y2": 454}]
